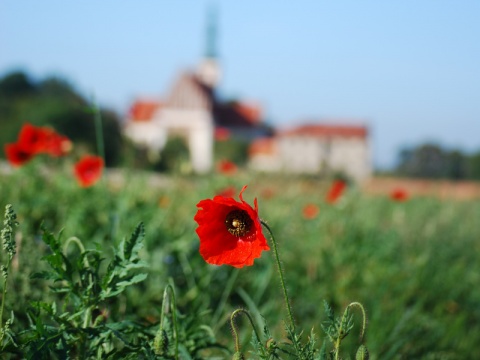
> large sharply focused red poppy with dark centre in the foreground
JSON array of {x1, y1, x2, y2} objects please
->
[{"x1": 194, "y1": 186, "x2": 270, "y2": 268}]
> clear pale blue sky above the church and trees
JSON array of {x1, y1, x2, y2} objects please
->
[{"x1": 0, "y1": 0, "x2": 480, "y2": 167}]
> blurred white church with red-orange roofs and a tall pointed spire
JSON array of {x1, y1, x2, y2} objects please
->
[{"x1": 124, "y1": 9, "x2": 266, "y2": 173}]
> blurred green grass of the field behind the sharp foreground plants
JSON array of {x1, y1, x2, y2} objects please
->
[{"x1": 0, "y1": 164, "x2": 480, "y2": 359}]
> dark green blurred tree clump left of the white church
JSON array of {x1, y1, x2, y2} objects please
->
[{"x1": 0, "y1": 72, "x2": 123, "y2": 166}]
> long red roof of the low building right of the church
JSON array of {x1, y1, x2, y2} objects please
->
[{"x1": 277, "y1": 124, "x2": 368, "y2": 138}]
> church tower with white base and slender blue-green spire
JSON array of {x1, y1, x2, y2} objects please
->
[{"x1": 197, "y1": 7, "x2": 221, "y2": 89}]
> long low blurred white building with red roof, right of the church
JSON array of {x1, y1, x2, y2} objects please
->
[{"x1": 249, "y1": 122, "x2": 372, "y2": 181}]
